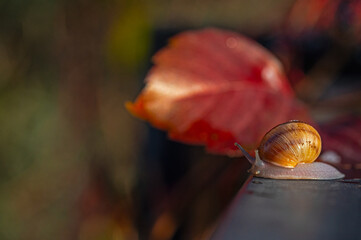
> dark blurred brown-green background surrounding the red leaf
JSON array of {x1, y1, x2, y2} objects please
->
[{"x1": 0, "y1": 0, "x2": 361, "y2": 240}]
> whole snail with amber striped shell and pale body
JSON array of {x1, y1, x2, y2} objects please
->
[{"x1": 235, "y1": 120, "x2": 345, "y2": 180}]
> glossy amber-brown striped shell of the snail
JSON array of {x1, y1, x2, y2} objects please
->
[{"x1": 258, "y1": 121, "x2": 322, "y2": 168}]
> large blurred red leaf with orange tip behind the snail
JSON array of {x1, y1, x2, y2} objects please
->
[{"x1": 126, "y1": 29, "x2": 310, "y2": 155}]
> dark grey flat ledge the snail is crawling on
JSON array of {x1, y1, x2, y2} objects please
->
[{"x1": 211, "y1": 178, "x2": 361, "y2": 240}]
